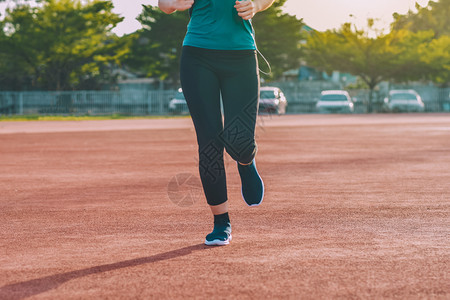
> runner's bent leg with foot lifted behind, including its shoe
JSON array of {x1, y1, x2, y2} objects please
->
[{"x1": 220, "y1": 51, "x2": 264, "y2": 206}]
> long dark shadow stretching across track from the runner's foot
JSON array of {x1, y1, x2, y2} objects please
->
[{"x1": 0, "y1": 244, "x2": 212, "y2": 300}]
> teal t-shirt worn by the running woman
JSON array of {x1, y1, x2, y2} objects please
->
[{"x1": 183, "y1": 0, "x2": 256, "y2": 50}]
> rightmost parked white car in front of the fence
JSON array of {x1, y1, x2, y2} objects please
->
[{"x1": 384, "y1": 90, "x2": 425, "y2": 112}]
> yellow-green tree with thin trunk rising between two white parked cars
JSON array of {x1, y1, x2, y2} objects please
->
[{"x1": 305, "y1": 19, "x2": 432, "y2": 112}]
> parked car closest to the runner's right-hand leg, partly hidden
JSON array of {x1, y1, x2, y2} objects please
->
[{"x1": 259, "y1": 86, "x2": 287, "y2": 115}]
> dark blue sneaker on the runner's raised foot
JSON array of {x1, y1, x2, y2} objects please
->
[{"x1": 238, "y1": 159, "x2": 264, "y2": 206}]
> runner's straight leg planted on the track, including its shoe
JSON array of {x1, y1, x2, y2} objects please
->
[{"x1": 180, "y1": 47, "x2": 231, "y2": 245}]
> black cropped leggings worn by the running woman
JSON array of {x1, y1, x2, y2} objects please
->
[{"x1": 180, "y1": 46, "x2": 259, "y2": 205}]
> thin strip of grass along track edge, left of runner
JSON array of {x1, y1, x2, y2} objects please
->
[{"x1": 0, "y1": 114, "x2": 189, "y2": 122}]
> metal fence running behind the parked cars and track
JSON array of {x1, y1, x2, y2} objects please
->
[{"x1": 0, "y1": 82, "x2": 450, "y2": 115}]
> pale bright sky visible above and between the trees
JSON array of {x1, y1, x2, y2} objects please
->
[{"x1": 0, "y1": 0, "x2": 429, "y2": 35}]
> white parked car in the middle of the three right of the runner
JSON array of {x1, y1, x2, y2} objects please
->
[{"x1": 316, "y1": 90, "x2": 354, "y2": 113}]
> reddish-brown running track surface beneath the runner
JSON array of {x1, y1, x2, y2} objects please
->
[{"x1": 0, "y1": 114, "x2": 450, "y2": 299}]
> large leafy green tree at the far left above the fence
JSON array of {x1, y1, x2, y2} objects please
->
[{"x1": 0, "y1": 0, "x2": 127, "y2": 90}]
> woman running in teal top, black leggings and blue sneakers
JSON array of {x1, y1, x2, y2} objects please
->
[{"x1": 158, "y1": 0, "x2": 274, "y2": 245}]
